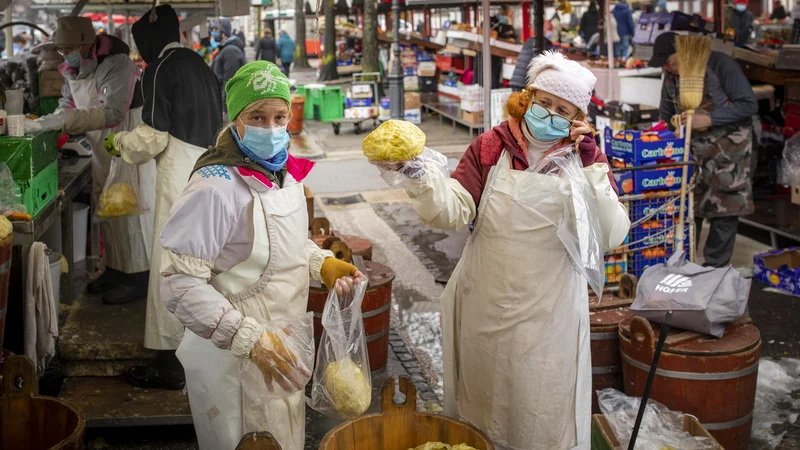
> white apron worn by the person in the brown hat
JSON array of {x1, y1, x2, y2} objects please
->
[{"x1": 68, "y1": 75, "x2": 156, "y2": 273}]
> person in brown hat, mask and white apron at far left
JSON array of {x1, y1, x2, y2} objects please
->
[{"x1": 25, "y1": 16, "x2": 156, "y2": 304}]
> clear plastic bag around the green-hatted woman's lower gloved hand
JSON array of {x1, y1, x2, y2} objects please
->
[{"x1": 239, "y1": 312, "x2": 314, "y2": 404}]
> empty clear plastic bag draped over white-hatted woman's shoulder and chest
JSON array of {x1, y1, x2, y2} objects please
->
[{"x1": 519, "y1": 145, "x2": 605, "y2": 298}]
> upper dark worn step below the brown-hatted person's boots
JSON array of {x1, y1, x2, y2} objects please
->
[{"x1": 58, "y1": 295, "x2": 156, "y2": 377}]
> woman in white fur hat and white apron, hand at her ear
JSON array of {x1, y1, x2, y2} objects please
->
[{"x1": 372, "y1": 52, "x2": 630, "y2": 450}]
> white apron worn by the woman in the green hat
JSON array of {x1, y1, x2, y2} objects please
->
[{"x1": 177, "y1": 174, "x2": 308, "y2": 450}]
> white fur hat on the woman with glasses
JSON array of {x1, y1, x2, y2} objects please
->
[{"x1": 528, "y1": 51, "x2": 597, "y2": 114}]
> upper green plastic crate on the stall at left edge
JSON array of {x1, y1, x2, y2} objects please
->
[{"x1": 0, "y1": 131, "x2": 58, "y2": 183}]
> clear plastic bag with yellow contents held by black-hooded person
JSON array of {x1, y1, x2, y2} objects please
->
[{"x1": 95, "y1": 157, "x2": 150, "y2": 220}]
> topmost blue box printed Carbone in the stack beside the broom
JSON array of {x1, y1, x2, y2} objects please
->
[{"x1": 603, "y1": 127, "x2": 685, "y2": 165}]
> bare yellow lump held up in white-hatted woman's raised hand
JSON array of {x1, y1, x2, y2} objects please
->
[{"x1": 361, "y1": 120, "x2": 425, "y2": 161}]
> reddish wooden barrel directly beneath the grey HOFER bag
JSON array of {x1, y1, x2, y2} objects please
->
[{"x1": 619, "y1": 317, "x2": 761, "y2": 450}]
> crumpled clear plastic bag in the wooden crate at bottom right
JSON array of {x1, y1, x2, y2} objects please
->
[{"x1": 597, "y1": 388, "x2": 717, "y2": 450}]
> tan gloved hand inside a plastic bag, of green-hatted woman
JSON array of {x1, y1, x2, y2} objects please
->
[{"x1": 250, "y1": 328, "x2": 311, "y2": 392}]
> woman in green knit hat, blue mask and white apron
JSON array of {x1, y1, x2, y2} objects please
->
[{"x1": 161, "y1": 61, "x2": 363, "y2": 450}]
